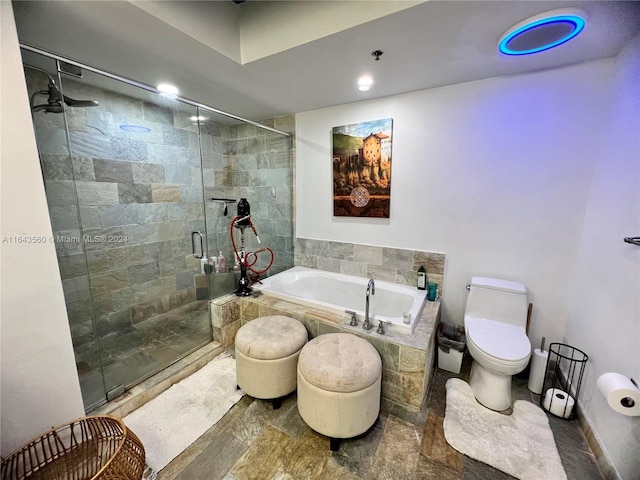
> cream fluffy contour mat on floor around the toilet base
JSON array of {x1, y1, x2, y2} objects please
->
[{"x1": 444, "y1": 378, "x2": 567, "y2": 480}]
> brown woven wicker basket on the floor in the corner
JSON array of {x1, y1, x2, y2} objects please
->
[{"x1": 2, "y1": 415, "x2": 145, "y2": 480}]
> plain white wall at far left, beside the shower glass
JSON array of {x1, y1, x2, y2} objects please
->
[{"x1": 0, "y1": 1, "x2": 84, "y2": 456}]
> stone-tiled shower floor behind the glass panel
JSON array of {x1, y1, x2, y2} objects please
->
[{"x1": 77, "y1": 302, "x2": 212, "y2": 412}]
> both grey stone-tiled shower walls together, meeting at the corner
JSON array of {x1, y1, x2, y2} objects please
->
[{"x1": 25, "y1": 70, "x2": 294, "y2": 372}]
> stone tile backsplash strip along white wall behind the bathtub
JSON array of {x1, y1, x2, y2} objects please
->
[{"x1": 294, "y1": 238, "x2": 445, "y2": 296}]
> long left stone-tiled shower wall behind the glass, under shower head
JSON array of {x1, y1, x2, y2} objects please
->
[{"x1": 27, "y1": 70, "x2": 213, "y2": 356}]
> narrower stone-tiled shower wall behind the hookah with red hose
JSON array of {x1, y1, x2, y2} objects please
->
[{"x1": 204, "y1": 116, "x2": 295, "y2": 281}]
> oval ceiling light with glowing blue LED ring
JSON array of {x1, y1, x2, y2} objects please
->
[{"x1": 498, "y1": 10, "x2": 586, "y2": 55}]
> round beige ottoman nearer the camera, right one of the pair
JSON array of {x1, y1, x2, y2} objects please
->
[{"x1": 298, "y1": 333, "x2": 382, "y2": 451}]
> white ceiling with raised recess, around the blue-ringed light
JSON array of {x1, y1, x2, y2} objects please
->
[{"x1": 13, "y1": 0, "x2": 640, "y2": 121}]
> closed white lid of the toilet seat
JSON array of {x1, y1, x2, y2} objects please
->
[{"x1": 465, "y1": 317, "x2": 531, "y2": 361}]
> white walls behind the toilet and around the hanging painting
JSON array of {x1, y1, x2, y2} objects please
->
[{"x1": 296, "y1": 39, "x2": 640, "y2": 480}]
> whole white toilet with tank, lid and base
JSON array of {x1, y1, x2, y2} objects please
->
[{"x1": 464, "y1": 277, "x2": 531, "y2": 411}]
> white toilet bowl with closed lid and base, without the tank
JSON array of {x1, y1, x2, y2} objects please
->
[{"x1": 464, "y1": 315, "x2": 531, "y2": 411}]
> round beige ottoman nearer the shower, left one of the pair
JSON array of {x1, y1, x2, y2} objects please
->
[{"x1": 235, "y1": 315, "x2": 308, "y2": 409}]
